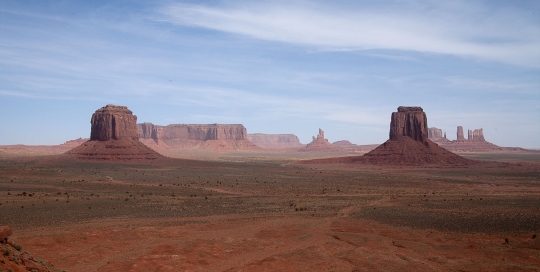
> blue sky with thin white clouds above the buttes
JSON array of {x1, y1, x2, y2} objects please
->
[{"x1": 0, "y1": 0, "x2": 540, "y2": 148}]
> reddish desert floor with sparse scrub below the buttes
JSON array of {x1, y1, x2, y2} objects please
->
[{"x1": 0, "y1": 154, "x2": 540, "y2": 271}]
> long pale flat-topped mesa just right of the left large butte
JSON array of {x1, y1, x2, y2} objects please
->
[{"x1": 136, "y1": 123, "x2": 259, "y2": 151}]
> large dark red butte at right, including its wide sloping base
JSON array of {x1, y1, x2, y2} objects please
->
[{"x1": 302, "y1": 106, "x2": 473, "y2": 165}]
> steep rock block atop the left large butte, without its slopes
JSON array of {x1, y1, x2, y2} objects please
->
[{"x1": 90, "y1": 104, "x2": 139, "y2": 141}]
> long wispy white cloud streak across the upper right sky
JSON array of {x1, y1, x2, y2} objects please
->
[{"x1": 154, "y1": 1, "x2": 540, "y2": 67}]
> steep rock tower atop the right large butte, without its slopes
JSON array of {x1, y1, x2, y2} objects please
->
[{"x1": 389, "y1": 106, "x2": 428, "y2": 142}]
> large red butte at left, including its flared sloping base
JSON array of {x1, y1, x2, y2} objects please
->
[{"x1": 66, "y1": 104, "x2": 162, "y2": 161}]
